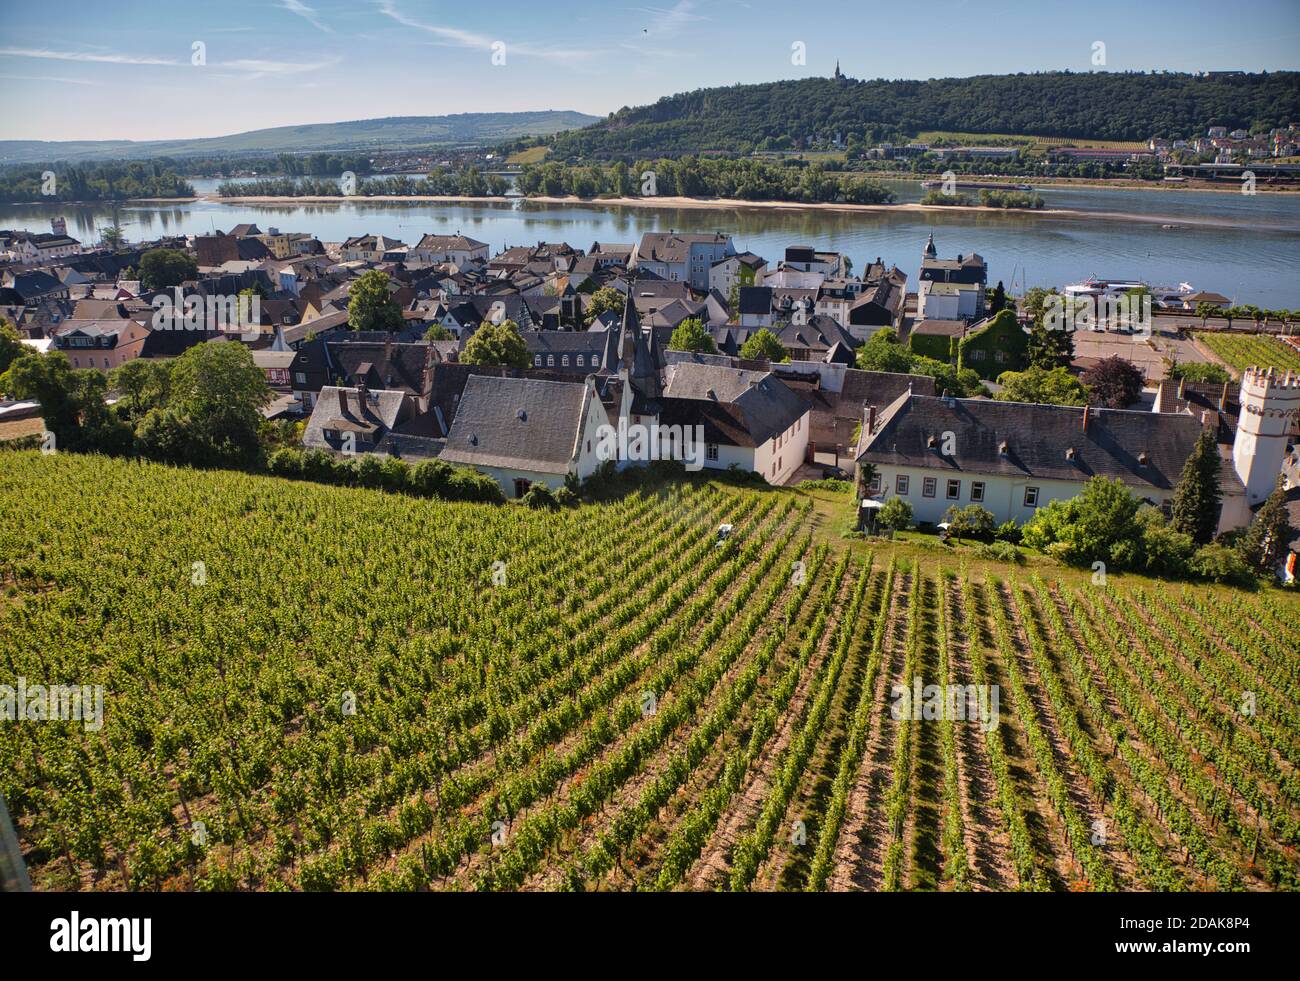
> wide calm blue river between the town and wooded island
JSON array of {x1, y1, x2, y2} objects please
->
[{"x1": 0, "y1": 179, "x2": 1300, "y2": 309}]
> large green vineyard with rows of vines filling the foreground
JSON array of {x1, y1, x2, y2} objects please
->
[{"x1": 0, "y1": 452, "x2": 1300, "y2": 890}]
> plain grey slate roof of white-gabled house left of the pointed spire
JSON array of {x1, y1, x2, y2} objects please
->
[{"x1": 442, "y1": 374, "x2": 588, "y2": 473}]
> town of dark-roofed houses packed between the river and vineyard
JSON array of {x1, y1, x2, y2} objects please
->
[{"x1": 0, "y1": 213, "x2": 1300, "y2": 577}]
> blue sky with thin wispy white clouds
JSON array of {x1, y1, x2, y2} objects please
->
[{"x1": 0, "y1": 0, "x2": 1300, "y2": 139}]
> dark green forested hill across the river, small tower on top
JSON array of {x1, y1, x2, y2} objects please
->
[{"x1": 551, "y1": 71, "x2": 1300, "y2": 159}]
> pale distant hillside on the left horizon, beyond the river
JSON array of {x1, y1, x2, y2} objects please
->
[{"x1": 0, "y1": 110, "x2": 598, "y2": 164}]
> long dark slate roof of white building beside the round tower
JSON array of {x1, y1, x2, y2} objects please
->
[{"x1": 858, "y1": 395, "x2": 1201, "y2": 490}]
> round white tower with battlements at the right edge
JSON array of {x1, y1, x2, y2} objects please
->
[{"x1": 1232, "y1": 368, "x2": 1300, "y2": 507}]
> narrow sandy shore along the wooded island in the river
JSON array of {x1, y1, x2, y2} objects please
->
[{"x1": 203, "y1": 195, "x2": 1292, "y2": 231}]
